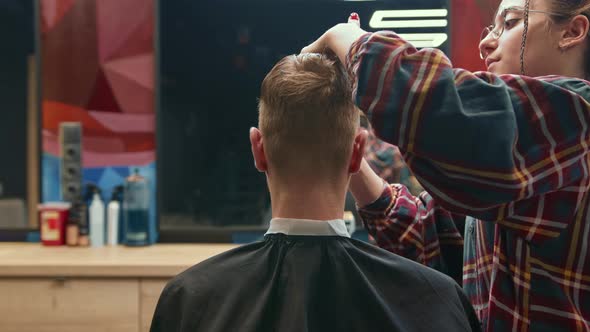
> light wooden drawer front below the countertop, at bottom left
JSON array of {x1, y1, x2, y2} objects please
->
[{"x1": 0, "y1": 278, "x2": 140, "y2": 332}]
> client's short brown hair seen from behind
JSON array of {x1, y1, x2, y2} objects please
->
[{"x1": 259, "y1": 53, "x2": 359, "y2": 179}]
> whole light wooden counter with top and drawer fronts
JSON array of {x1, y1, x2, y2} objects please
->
[{"x1": 0, "y1": 243, "x2": 236, "y2": 332}]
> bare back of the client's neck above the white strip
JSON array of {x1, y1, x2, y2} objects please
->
[{"x1": 270, "y1": 185, "x2": 346, "y2": 220}]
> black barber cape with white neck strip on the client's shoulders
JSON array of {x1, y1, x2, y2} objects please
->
[{"x1": 151, "y1": 219, "x2": 480, "y2": 332}]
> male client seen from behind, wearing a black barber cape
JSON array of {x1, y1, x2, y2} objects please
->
[{"x1": 151, "y1": 54, "x2": 479, "y2": 332}]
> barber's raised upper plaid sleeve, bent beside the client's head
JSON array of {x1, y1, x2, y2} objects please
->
[{"x1": 347, "y1": 32, "x2": 590, "y2": 242}]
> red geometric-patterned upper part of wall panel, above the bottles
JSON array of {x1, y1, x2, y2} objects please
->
[{"x1": 40, "y1": 0, "x2": 155, "y2": 167}]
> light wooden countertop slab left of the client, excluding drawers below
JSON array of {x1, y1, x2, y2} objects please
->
[{"x1": 0, "y1": 243, "x2": 236, "y2": 278}]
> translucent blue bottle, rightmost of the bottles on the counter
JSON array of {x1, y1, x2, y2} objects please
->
[{"x1": 123, "y1": 169, "x2": 150, "y2": 246}]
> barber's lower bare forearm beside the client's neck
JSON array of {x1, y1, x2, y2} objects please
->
[{"x1": 349, "y1": 159, "x2": 383, "y2": 207}]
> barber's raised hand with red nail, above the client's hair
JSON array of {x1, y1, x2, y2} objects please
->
[{"x1": 301, "y1": 13, "x2": 366, "y2": 63}]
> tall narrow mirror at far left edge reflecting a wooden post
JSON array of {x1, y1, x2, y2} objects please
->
[{"x1": 0, "y1": 0, "x2": 40, "y2": 236}]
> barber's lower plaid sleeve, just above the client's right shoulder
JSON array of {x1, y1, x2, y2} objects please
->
[{"x1": 359, "y1": 184, "x2": 463, "y2": 284}]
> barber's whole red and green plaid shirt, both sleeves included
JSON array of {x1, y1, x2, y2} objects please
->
[{"x1": 347, "y1": 32, "x2": 590, "y2": 331}]
